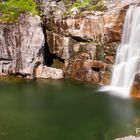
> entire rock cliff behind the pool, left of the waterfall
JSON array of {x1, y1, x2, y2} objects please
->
[{"x1": 0, "y1": 0, "x2": 128, "y2": 84}]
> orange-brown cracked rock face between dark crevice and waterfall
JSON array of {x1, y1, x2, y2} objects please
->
[{"x1": 39, "y1": 1, "x2": 128, "y2": 84}]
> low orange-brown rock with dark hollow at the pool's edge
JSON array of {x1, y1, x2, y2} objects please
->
[{"x1": 65, "y1": 59, "x2": 110, "y2": 83}]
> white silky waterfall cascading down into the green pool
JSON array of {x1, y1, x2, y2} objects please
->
[{"x1": 101, "y1": 5, "x2": 140, "y2": 97}]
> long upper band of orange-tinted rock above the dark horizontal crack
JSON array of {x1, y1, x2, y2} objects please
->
[{"x1": 46, "y1": 3, "x2": 128, "y2": 41}]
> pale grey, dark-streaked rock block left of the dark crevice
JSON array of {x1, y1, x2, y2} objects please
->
[{"x1": 0, "y1": 15, "x2": 44, "y2": 78}]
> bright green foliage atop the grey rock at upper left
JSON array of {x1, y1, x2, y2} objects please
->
[{"x1": 0, "y1": 0, "x2": 38, "y2": 21}]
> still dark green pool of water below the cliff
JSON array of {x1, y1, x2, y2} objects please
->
[{"x1": 0, "y1": 78, "x2": 140, "y2": 140}]
